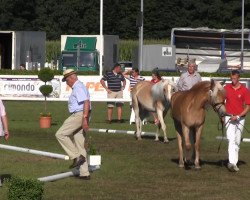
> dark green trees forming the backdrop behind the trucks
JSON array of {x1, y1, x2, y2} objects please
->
[{"x1": 0, "y1": 0, "x2": 250, "y2": 40}]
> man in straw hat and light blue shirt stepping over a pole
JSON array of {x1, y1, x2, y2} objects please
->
[{"x1": 56, "y1": 69, "x2": 91, "y2": 180}]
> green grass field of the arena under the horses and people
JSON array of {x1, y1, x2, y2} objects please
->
[{"x1": 0, "y1": 101, "x2": 250, "y2": 200}]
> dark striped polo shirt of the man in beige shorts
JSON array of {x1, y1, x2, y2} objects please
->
[{"x1": 102, "y1": 71, "x2": 125, "y2": 92}]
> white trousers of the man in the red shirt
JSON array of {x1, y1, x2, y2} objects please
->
[{"x1": 225, "y1": 116, "x2": 245, "y2": 165}]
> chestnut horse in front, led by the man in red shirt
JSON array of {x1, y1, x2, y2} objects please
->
[{"x1": 171, "y1": 79, "x2": 226, "y2": 169}]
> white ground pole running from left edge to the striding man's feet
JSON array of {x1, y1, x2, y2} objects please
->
[{"x1": 0, "y1": 144, "x2": 69, "y2": 160}]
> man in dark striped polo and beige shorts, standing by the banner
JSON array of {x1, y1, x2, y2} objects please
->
[{"x1": 100, "y1": 64, "x2": 126, "y2": 123}]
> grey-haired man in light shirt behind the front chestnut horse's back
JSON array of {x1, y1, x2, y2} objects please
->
[{"x1": 177, "y1": 60, "x2": 201, "y2": 91}]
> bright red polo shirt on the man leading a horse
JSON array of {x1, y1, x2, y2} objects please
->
[{"x1": 224, "y1": 83, "x2": 250, "y2": 115}]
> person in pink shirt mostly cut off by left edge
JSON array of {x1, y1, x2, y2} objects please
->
[{"x1": 0, "y1": 99, "x2": 10, "y2": 141}]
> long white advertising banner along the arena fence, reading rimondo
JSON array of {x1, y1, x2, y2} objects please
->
[{"x1": 0, "y1": 75, "x2": 247, "y2": 102}]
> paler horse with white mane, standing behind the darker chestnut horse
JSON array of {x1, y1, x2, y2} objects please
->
[{"x1": 131, "y1": 79, "x2": 176, "y2": 142}]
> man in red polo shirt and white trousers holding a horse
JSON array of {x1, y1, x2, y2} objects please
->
[{"x1": 224, "y1": 70, "x2": 250, "y2": 172}]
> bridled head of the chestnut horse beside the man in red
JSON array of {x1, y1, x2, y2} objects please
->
[{"x1": 209, "y1": 79, "x2": 227, "y2": 117}]
